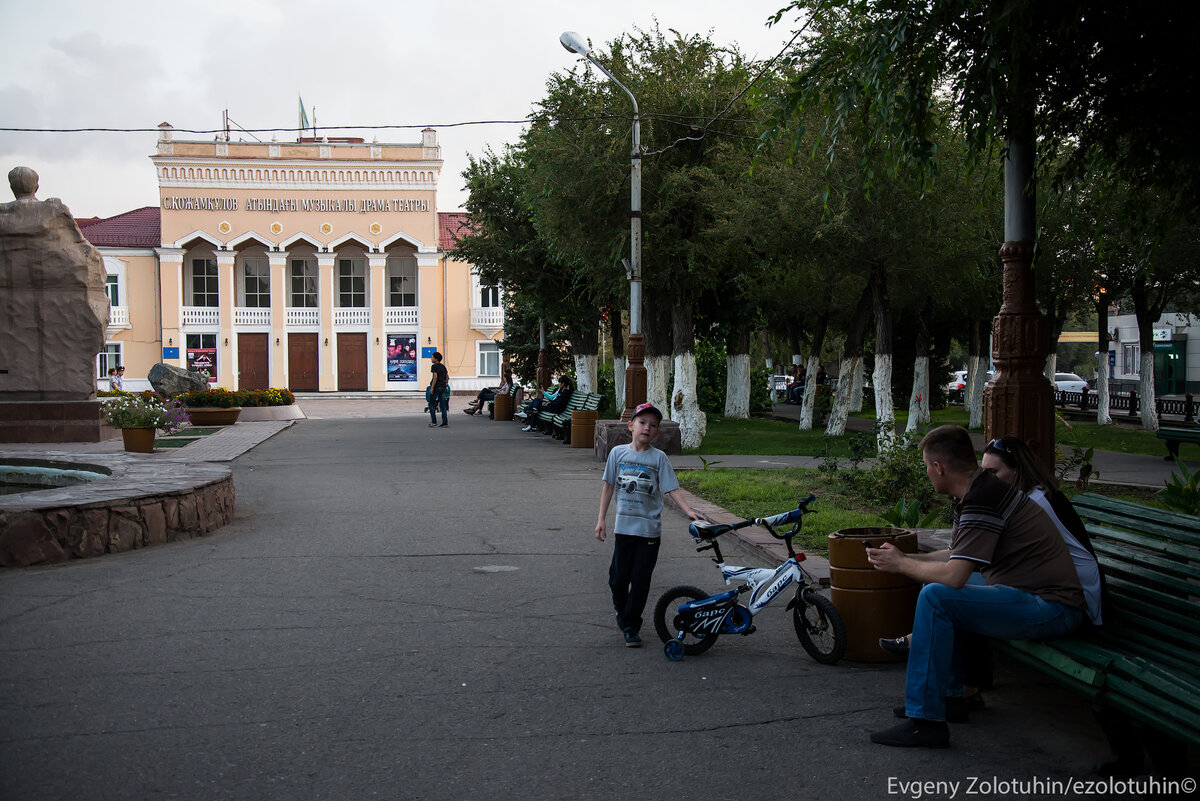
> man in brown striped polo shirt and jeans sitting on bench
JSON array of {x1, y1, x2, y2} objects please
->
[{"x1": 866, "y1": 426, "x2": 1087, "y2": 748}]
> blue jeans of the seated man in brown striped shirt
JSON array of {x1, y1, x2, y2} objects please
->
[{"x1": 905, "y1": 573, "x2": 1084, "y2": 721}]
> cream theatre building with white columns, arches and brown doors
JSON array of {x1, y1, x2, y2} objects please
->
[{"x1": 80, "y1": 122, "x2": 504, "y2": 395}]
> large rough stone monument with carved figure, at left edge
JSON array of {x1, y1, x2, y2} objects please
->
[{"x1": 0, "y1": 167, "x2": 113, "y2": 442}]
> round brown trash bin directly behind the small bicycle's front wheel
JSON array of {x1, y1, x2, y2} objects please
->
[{"x1": 829, "y1": 526, "x2": 920, "y2": 662}]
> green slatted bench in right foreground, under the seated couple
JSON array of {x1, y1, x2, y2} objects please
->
[{"x1": 997, "y1": 493, "x2": 1200, "y2": 761}]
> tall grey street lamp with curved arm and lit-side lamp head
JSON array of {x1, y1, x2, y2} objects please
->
[{"x1": 558, "y1": 31, "x2": 646, "y2": 421}]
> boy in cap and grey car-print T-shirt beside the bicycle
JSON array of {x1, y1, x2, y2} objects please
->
[{"x1": 596, "y1": 403, "x2": 704, "y2": 648}]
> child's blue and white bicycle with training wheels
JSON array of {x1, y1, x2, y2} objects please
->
[{"x1": 654, "y1": 495, "x2": 846, "y2": 664}]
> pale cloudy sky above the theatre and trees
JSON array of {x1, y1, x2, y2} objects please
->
[{"x1": 0, "y1": 0, "x2": 794, "y2": 217}]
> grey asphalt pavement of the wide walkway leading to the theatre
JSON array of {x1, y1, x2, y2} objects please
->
[{"x1": 0, "y1": 401, "x2": 1190, "y2": 801}]
